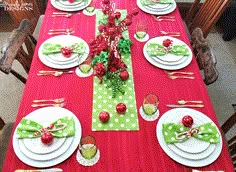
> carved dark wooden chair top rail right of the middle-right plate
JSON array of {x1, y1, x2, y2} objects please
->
[{"x1": 191, "y1": 28, "x2": 219, "y2": 85}]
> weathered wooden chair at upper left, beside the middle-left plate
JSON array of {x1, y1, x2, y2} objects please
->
[{"x1": 0, "y1": 19, "x2": 37, "y2": 83}]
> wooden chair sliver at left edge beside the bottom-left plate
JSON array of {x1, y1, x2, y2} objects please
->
[{"x1": 0, "y1": 117, "x2": 14, "y2": 171}]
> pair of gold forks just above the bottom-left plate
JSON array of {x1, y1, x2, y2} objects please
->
[{"x1": 31, "y1": 98, "x2": 66, "y2": 107}]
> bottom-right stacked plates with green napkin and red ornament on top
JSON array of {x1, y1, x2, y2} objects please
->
[{"x1": 156, "y1": 108, "x2": 222, "y2": 167}]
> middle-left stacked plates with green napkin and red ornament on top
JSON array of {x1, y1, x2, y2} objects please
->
[{"x1": 38, "y1": 35, "x2": 89, "y2": 69}]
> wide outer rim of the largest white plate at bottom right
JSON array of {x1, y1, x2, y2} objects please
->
[{"x1": 156, "y1": 108, "x2": 222, "y2": 167}]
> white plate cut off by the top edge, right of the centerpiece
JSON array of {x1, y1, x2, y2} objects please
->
[{"x1": 137, "y1": 0, "x2": 176, "y2": 15}]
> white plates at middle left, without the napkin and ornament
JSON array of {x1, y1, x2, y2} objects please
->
[{"x1": 38, "y1": 35, "x2": 89, "y2": 69}]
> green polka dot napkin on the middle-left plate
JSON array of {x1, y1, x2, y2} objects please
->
[{"x1": 42, "y1": 42, "x2": 85, "y2": 55}]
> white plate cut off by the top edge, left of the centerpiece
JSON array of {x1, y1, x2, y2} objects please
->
[{"x1": 51, "y1": 0, "x2": 92, "y2": 11}]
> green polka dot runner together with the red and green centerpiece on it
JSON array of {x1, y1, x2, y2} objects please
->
[{"x1": 89, "y1": 0, "x2": 139, "y2": 131}]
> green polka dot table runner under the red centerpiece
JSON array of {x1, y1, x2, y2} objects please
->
[{"x1": 92, "y1": 10, "x2": 139, "y2": 131}]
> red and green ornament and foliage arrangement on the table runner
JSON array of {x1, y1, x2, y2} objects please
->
[{"x1": 89, "y1": 0, "x2": 139, "y2": 98}]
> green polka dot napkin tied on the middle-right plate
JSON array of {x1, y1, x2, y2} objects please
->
[{"x1": 146, "y1": 43, "x2": 190, "y2": 56}]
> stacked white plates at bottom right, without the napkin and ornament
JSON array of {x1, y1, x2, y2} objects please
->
[{"x1": 156, "y1": 108, "x2": 222, "y2": 167}]
